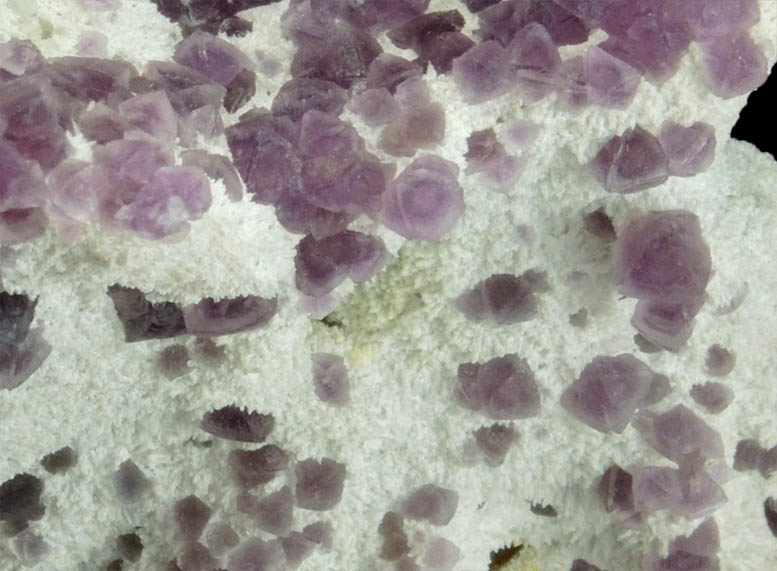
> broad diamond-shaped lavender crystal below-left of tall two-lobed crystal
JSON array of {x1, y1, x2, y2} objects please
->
[{"x1": 561, "y1": 353, "x2": 653, "y2": 434}]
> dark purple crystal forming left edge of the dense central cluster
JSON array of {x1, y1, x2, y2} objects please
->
[{"x1": 226, "y1": 113, "x2": 302, "y2": 204}]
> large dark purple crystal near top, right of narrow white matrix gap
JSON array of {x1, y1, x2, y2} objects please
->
[{"x1": 291, "y1": 21, "x2": 383, "y2": 89}]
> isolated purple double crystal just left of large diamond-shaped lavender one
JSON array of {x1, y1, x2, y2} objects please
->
[{"x1": 453, "y1": 353, "x2": 540, "y2": 420}]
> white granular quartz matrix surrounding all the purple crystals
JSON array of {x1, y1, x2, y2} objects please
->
[{"x1": 0, "y1": 0, "x2": 777, "y2": 571}]
